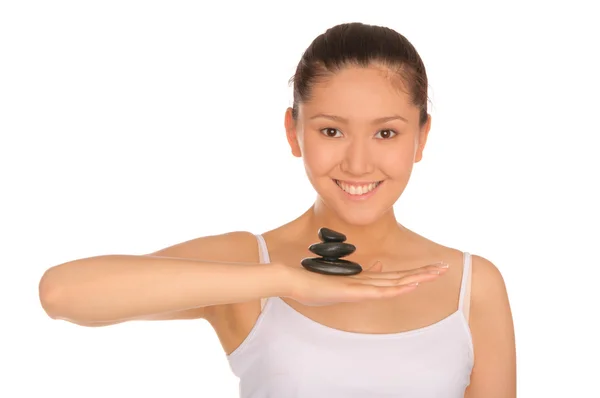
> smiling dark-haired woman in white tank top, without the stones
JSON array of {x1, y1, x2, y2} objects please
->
[{"x1": 40, "y1": 23, "x2": 516, "y2": 398}]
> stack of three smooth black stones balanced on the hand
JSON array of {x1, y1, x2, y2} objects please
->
[{"x1": 301, "y1": 228, "x2": 362, "y2": 275}]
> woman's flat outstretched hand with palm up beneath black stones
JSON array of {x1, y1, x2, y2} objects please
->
[{"x1": 289, "y1": 261, "x2": 448, "y2": 306}]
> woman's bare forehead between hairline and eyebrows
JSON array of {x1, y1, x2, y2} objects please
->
[{"x1": 301, "y1": 67, "x2": 419, "y2": 119}]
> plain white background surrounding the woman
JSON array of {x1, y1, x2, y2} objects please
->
[{"x1": 0, "y1": 1, "x2": 600, "y2": 398}]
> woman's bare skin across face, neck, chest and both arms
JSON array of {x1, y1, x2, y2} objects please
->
[{"x1": 40, "y1": 66, "x2": 516, "y2": 398}]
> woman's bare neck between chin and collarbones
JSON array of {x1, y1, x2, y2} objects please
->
[{"x1": 303, "y1": 198, "x2": 407, "y2": 249}]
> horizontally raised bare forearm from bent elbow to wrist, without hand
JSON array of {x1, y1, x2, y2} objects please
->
[{"x1": 40, "y1": 255, "x2": 287, "y2": 323}]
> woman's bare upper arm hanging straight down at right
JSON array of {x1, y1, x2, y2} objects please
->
[{"x1": 465, "y1": 256, "x2": 517, "y2": 398}]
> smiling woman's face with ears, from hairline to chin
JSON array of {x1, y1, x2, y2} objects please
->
[{"x1": 285, "y1": 68, "x2": 430, "y2": 225}]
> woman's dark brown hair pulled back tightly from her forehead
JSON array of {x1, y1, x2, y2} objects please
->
[{"x1": 290, "y1": 22, "x2": 427, "y2": 126}]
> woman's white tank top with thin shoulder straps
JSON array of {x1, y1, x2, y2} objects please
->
[{"x1": 228, "y1": 235, "x2": 474, "y2": 398}]
